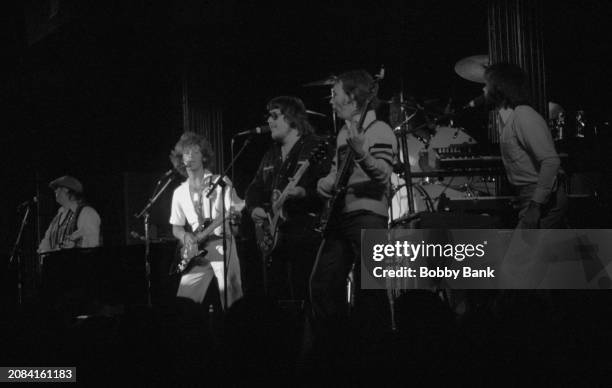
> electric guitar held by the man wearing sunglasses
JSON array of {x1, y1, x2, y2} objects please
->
[{"x1": 255, "y1": 141, "x2": 328, "y2": 265}]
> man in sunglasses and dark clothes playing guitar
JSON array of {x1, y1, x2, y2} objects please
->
[{"x1": 246, "y1": 96, "x2": 330, "y2": 301}]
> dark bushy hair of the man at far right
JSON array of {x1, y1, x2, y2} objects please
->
[{"x1": 485, "y1": 63, "x2": 530, "y2": 109}]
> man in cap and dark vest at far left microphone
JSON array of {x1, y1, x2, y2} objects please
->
[{"x1": 38, "y1": 175, "x2": 100, "y2": 253}]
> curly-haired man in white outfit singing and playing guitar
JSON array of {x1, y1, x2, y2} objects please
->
[{"x1": 170, "y1": 132, "x2": 244, "y2": 308}]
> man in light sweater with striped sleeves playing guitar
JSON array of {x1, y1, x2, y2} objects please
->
[{"x1": 310, "y1": 70, "x2": 397, "y2": 346}]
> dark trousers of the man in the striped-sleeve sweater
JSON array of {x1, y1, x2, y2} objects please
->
[{"x1": 310, "y1": 211, "x2": 390, "y2": 343}]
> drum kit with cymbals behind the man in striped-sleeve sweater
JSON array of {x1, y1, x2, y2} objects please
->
[{"x1": 302, "y1": 55, "x2": 498, "y2": 224}]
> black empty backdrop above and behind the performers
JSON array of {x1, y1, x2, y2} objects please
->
[{"x1": 0, "y1": 0, "x2": 612, "y2": 252}]
